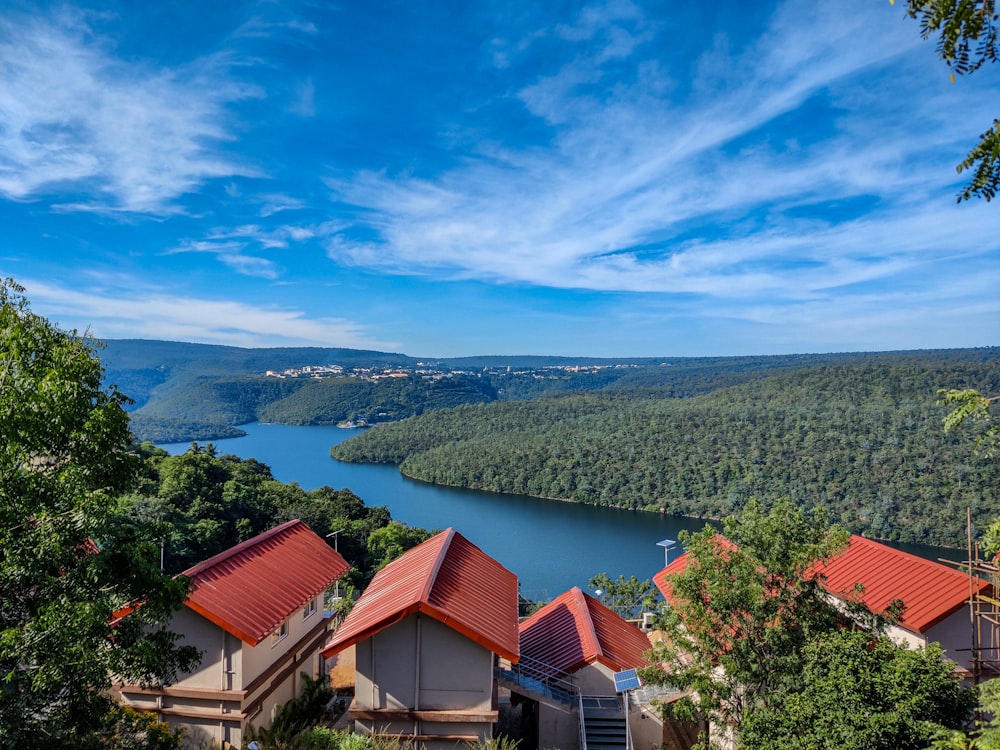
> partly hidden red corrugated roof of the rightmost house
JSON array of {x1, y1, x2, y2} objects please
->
[{"x1": 653, "y1": 535, "x2": 989, "y2": 633}]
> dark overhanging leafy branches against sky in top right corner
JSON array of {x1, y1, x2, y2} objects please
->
[{"x1": 890, "y1": 0, "x2": 1000, "y2": 201}]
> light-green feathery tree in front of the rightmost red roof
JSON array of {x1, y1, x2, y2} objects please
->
[{"x1": 645, "y1": 500, "x2": 847, "y2": 747}]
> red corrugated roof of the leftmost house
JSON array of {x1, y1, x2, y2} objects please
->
[{"x1": 183, "y1": 520, "x2": 350, "y2": 646}]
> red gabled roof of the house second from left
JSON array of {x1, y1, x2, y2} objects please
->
[{"x1": 323, "y1": 529, "x2": 519, "y2": 662}]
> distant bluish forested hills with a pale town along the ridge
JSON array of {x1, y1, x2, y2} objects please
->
[{"x1": 99, "y1": 340, "x2": 1000, "y2": 450}]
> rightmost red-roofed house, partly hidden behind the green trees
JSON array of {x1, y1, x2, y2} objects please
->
[{"x1": 653, "y1": 535, "x2": 1000, "y2": 670}]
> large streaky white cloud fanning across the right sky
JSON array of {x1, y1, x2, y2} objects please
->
[{"x1": 327, "y1": 3, "x2": 996, "y2": 306}]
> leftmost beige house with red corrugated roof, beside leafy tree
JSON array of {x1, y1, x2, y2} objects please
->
[{"x1": 116, "y1": 520, "x2": 349, "y2": 748}]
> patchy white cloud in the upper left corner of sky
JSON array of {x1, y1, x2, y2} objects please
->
[{"x1": 0, "y1": 11, "x2": 260, "y2": 214}]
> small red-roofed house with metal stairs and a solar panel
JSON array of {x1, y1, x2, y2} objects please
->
[{"x1": 507, "y1": 587, "x2": 663, "y2": 750}]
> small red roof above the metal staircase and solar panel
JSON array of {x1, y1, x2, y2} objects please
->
[{"x1": 520, "y1": 587, "x2": 650, "y2": 673}]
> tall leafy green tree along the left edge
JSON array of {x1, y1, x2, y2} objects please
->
[{"x1": 0, "y1": 279, "x2": 197, "y2": 749}]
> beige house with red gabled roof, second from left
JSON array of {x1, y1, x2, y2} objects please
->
[{"x1": 322, "y1": 529, "x2": 519, "y2": 750}]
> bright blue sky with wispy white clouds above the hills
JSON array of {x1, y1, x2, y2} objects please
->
[{"x1": 0, "y1": 0, "x2": 1000, "y2": 357}]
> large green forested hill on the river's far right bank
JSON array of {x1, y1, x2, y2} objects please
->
[{"x1": 332, "y1": 350, "x2": 1000, "y2": 545}]
